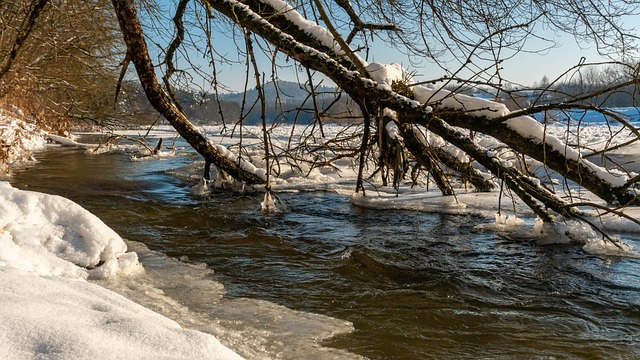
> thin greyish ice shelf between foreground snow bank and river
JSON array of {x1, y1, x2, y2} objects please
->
[{"x1": 97, "y1": 241, "x2": 360, "y2": 359}]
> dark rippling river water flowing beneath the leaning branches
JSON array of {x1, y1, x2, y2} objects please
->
[{"x1": 11, "y1": 136, "x2": 640, "y2": 359}]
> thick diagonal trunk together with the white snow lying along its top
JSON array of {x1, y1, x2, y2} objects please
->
[{"x1": 189, "y1": 0, "x2": 638, "y2": 204}]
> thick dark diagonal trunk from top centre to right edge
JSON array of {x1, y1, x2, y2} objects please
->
[{"x1": 196, "y1": 0, "x2": 638, "y2": 208}]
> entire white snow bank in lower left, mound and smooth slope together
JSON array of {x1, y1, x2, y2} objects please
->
[{"x1": 0, "y1": 182, "x2": 245, "y2": 359}]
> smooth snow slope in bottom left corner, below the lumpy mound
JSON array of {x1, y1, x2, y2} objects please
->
[{"x1": 0, "y1": 266, "x2": 240, "y2": 359}]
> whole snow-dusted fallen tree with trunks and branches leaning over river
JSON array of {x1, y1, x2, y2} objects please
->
[{"x1": 107, "y1": 0, "x2": 640, "y2": 225}]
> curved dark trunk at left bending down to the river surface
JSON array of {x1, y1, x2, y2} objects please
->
[{"x1": 113, "y1": 0, "x2": 265, "y2": 184}]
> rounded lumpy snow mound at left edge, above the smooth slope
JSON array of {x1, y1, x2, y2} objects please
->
[{"x1": 0, "y1": 182, "x2": 141, "y2": 278}]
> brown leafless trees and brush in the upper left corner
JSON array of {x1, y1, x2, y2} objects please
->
[{"x1": 0, "y1": 0, "x2": 124, "y2": 130}]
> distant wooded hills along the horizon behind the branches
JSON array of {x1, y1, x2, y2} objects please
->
[{"x1": 110, "y1": 80, "x2": 640, "y2": 126}]
